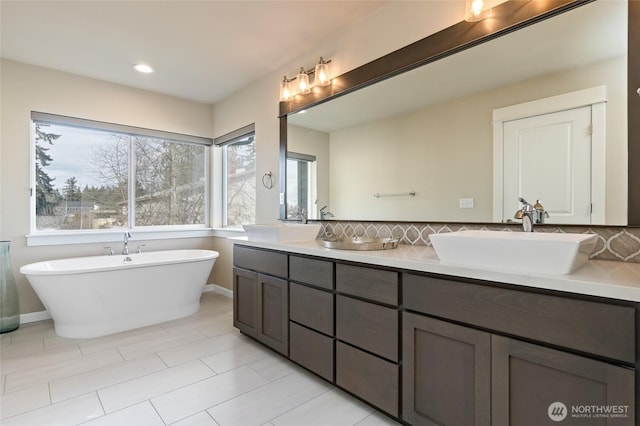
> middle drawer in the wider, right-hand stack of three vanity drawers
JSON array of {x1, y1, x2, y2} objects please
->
[{"x1": 336, "y1": 295, "x2": 399, "y2": 362}]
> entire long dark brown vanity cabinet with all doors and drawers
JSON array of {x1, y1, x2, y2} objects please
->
[{"x1": 233, "y1": 244, "x2": 640, "y2": 426}]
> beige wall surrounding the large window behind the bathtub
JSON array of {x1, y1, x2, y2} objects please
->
[{"x1": 0, "y1": 60, "x2": 217, "y2": 313}]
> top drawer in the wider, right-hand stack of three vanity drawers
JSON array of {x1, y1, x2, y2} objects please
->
[{"x1": 336, "y1": 264, "x2": 398, "y2": 306}]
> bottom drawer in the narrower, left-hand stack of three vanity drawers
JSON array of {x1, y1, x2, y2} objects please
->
[{"x1": 289, "y1": 322, "x2": 334, "y2": 382}]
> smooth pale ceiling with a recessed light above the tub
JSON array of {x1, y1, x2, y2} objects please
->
[{"x1": 0, "y1": 0, "x2": 388, "y2": 104}]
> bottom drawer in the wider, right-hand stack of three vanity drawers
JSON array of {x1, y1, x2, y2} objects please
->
[{"x1": 336, "y1": 342, "x2": 400, "y2": 416}]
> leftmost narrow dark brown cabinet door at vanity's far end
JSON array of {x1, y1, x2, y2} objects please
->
[{"x1": 233, "y1": 268, "x2": 258, "y2": 338}]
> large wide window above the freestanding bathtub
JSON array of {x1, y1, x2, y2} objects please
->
[{"x1": 32, "y1": 112, "x2": 212, "y2": 232}]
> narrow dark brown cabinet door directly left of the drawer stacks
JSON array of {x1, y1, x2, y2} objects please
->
[{"x1": 256, "y1": 274, "x2": 289, "y2": 355}]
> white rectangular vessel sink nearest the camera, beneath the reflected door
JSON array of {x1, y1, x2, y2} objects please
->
[{"x1": 429, "y1": 231, "x2": 597, "y2": 274}]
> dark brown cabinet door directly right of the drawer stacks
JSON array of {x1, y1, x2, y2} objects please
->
[{"x1": 402, "y1": 312, "x2": 492, "y2": 426}]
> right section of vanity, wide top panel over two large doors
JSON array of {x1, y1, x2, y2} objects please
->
[{"x1": 403, "y1": 274, "x2": 636, "y2": 426}]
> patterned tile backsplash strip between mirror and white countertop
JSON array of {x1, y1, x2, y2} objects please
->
[{"x1": 320, "y1": 221, "x2": 640, "y2": 263}]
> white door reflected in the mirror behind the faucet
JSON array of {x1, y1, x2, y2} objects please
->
[{"x1": 503, "y1": 106, "x2": 591, "y2": 224}]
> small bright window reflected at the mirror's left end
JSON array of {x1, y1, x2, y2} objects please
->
[{"x1": 287, "y1": 152, "x2": 317, "y2": 219}]
